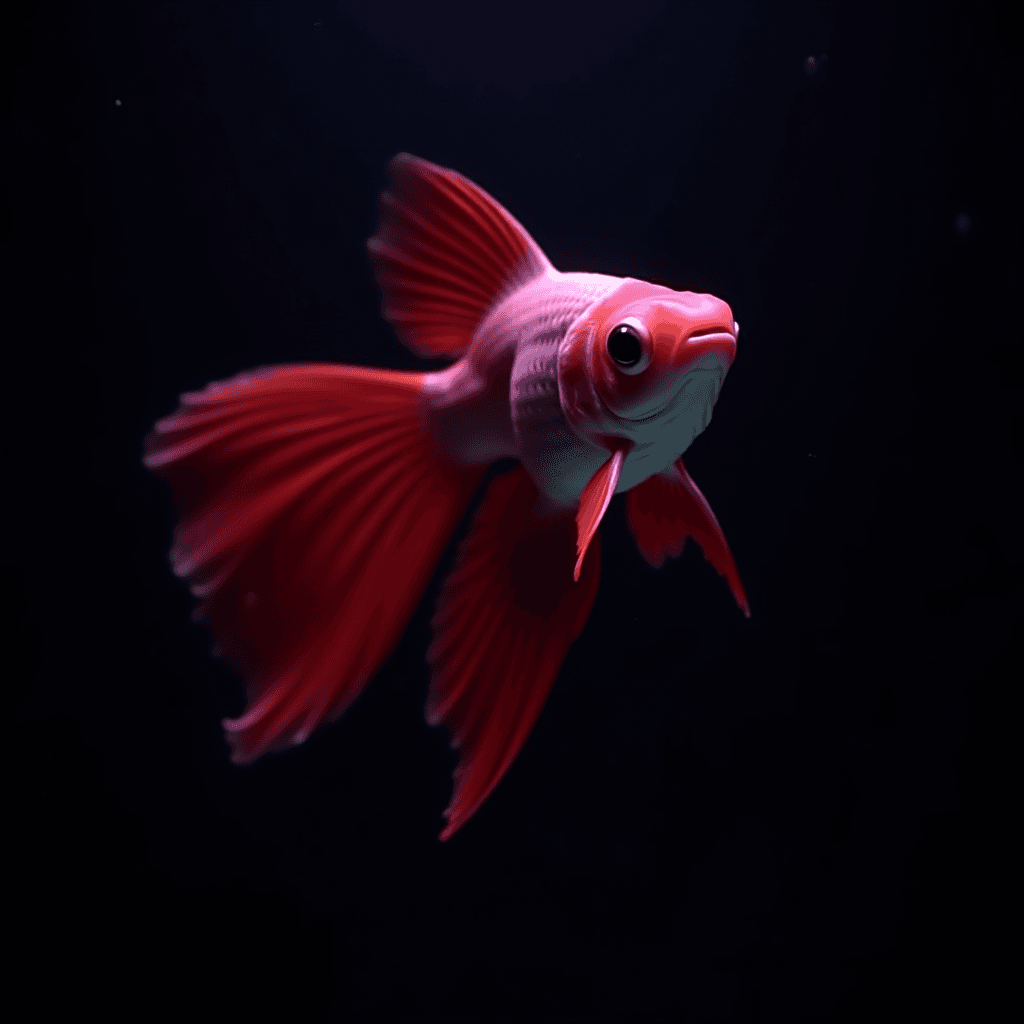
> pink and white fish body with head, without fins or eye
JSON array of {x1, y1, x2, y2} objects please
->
[{"x1": 425, "y1": 267, "x2": 736, "y2": 511}]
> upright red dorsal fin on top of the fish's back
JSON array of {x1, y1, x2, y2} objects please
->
[{"x1": 367, "y1": 153, "x2": 551, "y2": 357}]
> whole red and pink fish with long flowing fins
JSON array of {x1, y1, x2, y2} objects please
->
[{"x1": 144, "y1": 154, "x2": 750, "y2": 840}]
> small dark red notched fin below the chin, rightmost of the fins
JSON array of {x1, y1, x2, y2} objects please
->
[{"x1": 626, "y1": 459, "x2": 751, "y2": 618}]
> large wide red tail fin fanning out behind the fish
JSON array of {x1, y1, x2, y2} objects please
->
[{"x1": 144, "y1": 366, "x2": 479, "y2": 763}]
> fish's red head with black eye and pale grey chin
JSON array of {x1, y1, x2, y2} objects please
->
[{"x1": 558, "y1": 279, "x2": 739, "y2": 461}]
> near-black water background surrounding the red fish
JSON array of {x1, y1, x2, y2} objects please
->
[{"x1": 0, "y1": 0, "x2": 1022, "y2": 1022}]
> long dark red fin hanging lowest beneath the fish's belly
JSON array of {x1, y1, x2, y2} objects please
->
[{"x1": 427, "y1": 468, "x2": 601, "y2": 840}]
